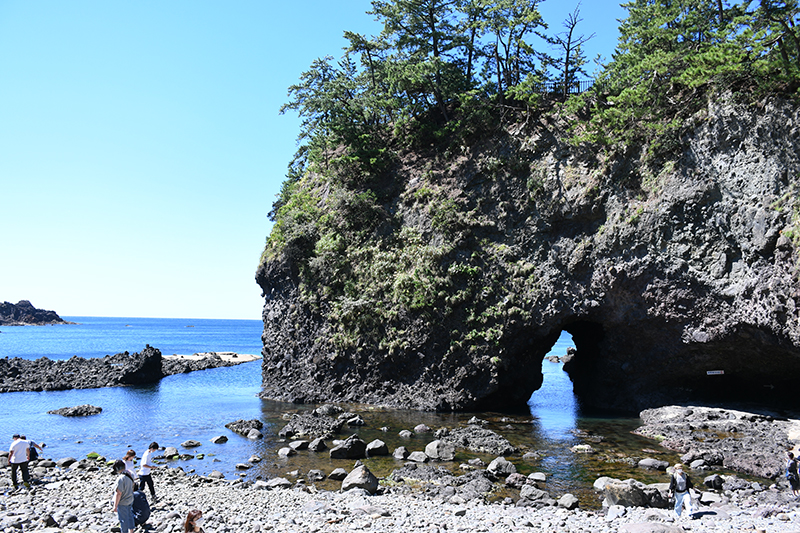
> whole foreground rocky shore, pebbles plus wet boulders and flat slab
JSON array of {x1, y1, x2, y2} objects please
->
[{"x1": 0, "y1": 405, "x2": 800, "y2": 533}]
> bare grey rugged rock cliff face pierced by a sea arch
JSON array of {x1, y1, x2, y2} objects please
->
[{"x1": 257, "y1": 95, "x2": 800, "y2": 411}]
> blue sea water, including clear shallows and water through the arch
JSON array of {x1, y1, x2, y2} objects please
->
[{"x1": 0, "y1": 317, "x2": 674, "y2": 506}]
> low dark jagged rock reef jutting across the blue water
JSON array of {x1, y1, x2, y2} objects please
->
[{"x1": 0, "y1": 345, "x2": 257, "y2": 393}]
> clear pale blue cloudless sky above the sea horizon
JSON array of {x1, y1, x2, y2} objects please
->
[{"x1": 0, "y1": 0, "x2": 625, "y2": 319}]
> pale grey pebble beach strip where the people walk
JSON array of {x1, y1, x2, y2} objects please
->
[{"x1": 0, "y1": 460, "x2": 800, "y2": 533}]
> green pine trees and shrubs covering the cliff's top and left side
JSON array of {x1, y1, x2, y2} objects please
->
[{"x1": 262, "y1": 0, "x2": 800, "y2": 408}]
